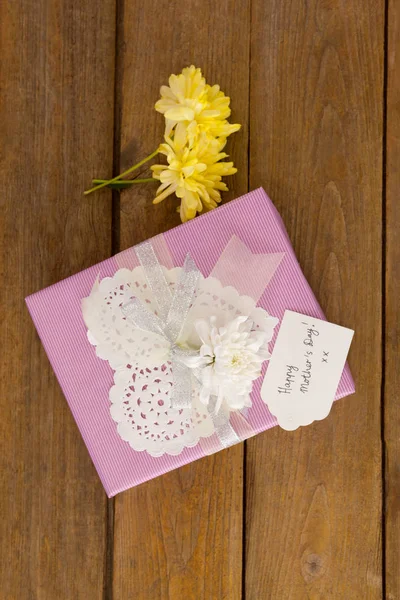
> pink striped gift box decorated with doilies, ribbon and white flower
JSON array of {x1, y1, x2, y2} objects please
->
[{"x1": 26, "y1": 189, "x2": 354, "y2": 497}]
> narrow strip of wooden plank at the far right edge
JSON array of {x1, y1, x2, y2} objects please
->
[{"x1": 384, "y1": 0, "x2": 400, "y2": 600}]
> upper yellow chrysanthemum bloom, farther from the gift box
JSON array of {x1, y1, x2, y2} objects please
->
[{"x1": 155, "y1": 65, "x2": 240, "y2": 137}]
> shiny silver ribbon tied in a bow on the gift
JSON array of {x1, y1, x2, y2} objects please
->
[{"x1": 121, "y1": 242, "x2": 240, "y2": 448}]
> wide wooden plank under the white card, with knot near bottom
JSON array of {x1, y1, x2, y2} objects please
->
[{"x1": 245, "y1": 0, "x2": 384, "y2": 600}]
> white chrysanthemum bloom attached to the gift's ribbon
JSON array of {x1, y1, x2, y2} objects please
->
[{"x1": 185, "y1": 316, "x2": 270, "y2": 412}]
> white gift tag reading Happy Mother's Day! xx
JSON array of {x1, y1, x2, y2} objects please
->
[{"x1": 261, "y1": 310, "x2": 354, "y2": 431}]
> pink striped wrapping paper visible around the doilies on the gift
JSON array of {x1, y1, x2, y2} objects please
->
[{"x1": 26, "y1": 188, "x2": 355, "y2": 497}]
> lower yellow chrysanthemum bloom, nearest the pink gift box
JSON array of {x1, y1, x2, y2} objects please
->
[{"x1": 151, "y1": 129, "x2": 237, "y2": 223}]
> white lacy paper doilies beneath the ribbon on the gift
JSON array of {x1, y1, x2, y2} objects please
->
[{"x1": 82, "y1": 267, "x2": 277, "y2": 456}]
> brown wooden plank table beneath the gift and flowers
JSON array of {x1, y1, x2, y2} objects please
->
[{"x1": 0, "y1": 0, "x2": 400, "y2": 600}]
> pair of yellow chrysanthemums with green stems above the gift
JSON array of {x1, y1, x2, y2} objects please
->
[{"x1": 85, "y1": 65, "x2": 240, "y2": 211}]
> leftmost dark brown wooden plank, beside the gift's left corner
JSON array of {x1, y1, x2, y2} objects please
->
[{"x1": 0, "y1": 0, "x2": 115, "y2": 600}]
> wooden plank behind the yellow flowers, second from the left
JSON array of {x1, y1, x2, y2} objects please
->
[{"x1": 113, "y1": 0, "x2": 250, "y2": 600}]
